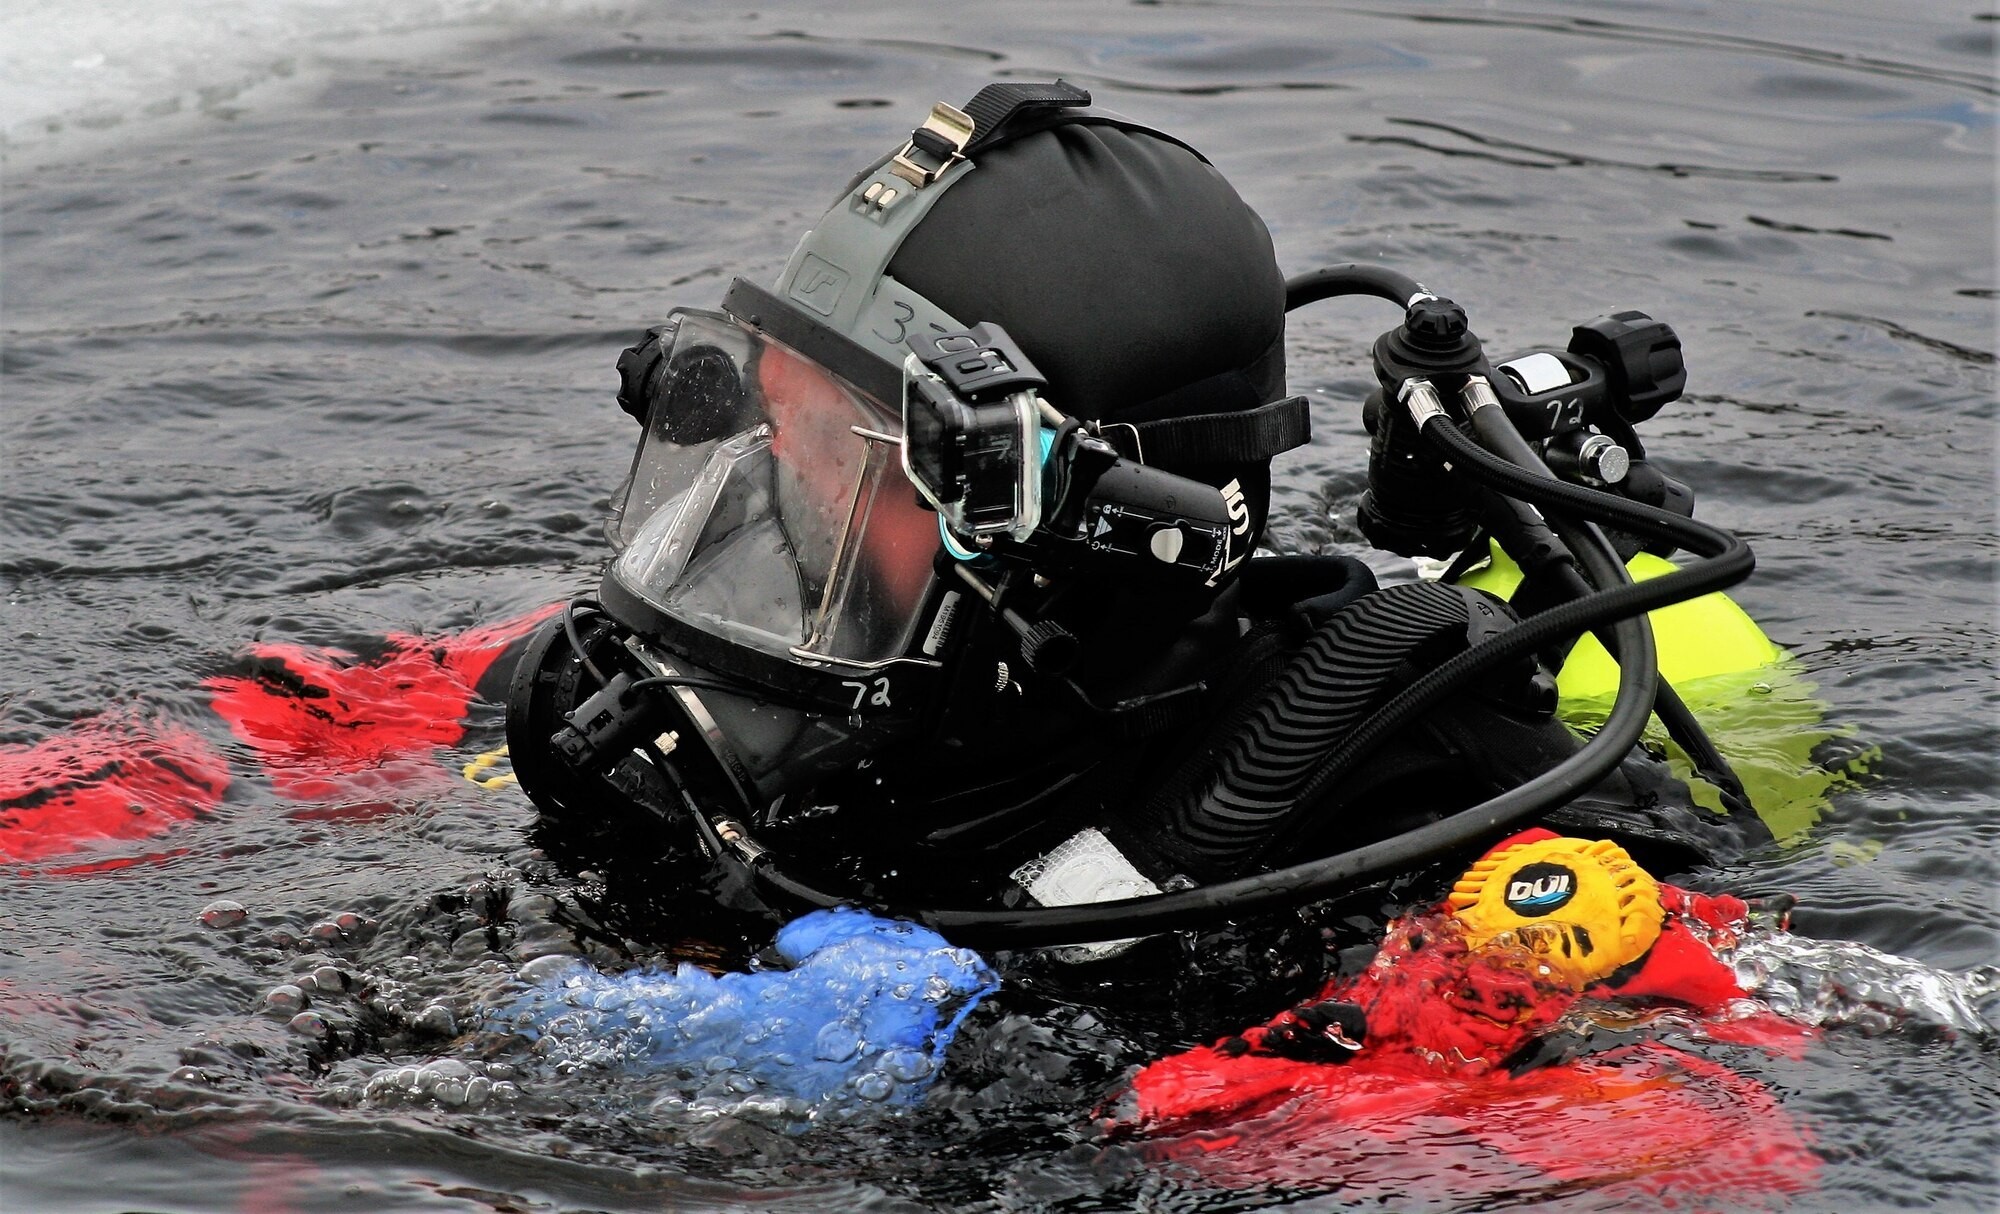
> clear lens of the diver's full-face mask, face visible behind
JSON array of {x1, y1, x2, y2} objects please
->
[{"x1": 612, "y1": 312, "x2": 938, "y2": 664}]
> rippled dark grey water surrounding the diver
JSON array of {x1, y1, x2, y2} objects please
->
[{"x1": 0, "y1": 0, "x2": 2000, "y2": 1214}]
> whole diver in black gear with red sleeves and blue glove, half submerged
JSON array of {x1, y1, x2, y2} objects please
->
[{"x1": 0, "y1": 82, "x2": 1952, "y2": 1196}]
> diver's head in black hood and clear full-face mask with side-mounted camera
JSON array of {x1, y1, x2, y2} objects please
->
[{"x1": 510, "y1": 82, "x2": 1304, "y2": 828}]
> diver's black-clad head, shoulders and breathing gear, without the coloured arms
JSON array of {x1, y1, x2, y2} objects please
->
[{"x1": 506, "y1": 80, "x2": 1758, "y2": 956}]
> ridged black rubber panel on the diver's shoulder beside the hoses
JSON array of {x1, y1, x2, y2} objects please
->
[{"x1": 1148, "y1": 584, "x2": 1468, "y2": 880}]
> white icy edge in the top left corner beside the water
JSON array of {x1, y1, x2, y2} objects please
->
[{"x1": 0, "y1": 0, "x2": 610, "y2": 150}]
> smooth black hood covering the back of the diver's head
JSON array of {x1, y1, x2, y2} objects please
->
[{"x1": 888, "y1": 120, "x2": 1284, "y2": 422}]
